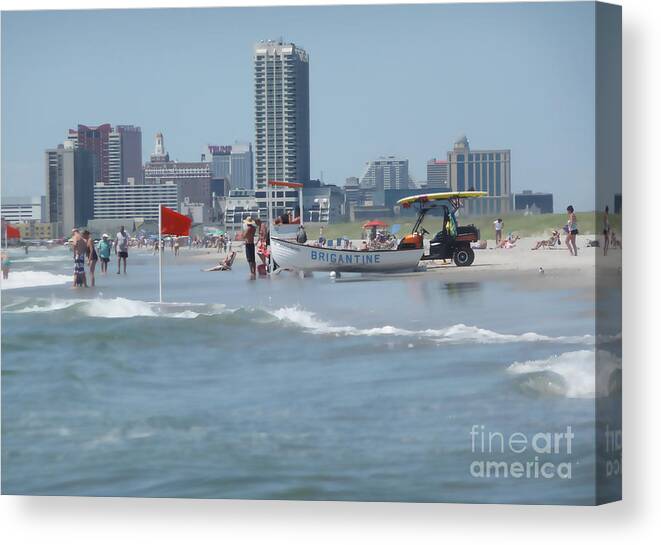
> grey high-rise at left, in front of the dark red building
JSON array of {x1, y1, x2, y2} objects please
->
[{"x1": 43, "y1": 140, "x2": 98, "y2": 236}]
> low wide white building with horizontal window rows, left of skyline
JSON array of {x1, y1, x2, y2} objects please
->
[{"x1": 94, "y1": 181, "x2": 179, "y2": 220}]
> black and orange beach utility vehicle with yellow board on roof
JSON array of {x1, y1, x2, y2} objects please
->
[{"x1": 398, "y1": 191, "x2": 486, "y2": 267}]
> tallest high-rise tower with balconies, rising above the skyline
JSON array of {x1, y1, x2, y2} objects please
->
[{"x1": 253, "y1": 41, "x2": 310, "y2": 189}]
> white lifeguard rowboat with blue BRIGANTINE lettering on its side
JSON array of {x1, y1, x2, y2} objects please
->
[{"x1": 271, "y1": 237, "x2": 424, "y2": 273}]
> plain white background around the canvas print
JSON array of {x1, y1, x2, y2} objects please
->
[{"x1": 0, "y1": 0, "x2": 661, "y2": 545}]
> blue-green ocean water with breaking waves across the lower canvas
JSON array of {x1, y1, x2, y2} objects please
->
[{"x1": 2, "y1": 245, "x2": 621, "y2": 504}]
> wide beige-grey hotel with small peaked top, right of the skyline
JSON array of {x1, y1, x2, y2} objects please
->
[{"x1": 448, "y1": 136, "x2": 512, "y2": 215}]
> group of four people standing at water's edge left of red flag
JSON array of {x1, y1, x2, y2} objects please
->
[{"x1": 70, "y1": 225, "x2": 130, "y2": 288}]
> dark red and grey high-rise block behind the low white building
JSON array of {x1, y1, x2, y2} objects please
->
[{"x1": 67, "y1": 123, "x2": 142, "y2": 184}]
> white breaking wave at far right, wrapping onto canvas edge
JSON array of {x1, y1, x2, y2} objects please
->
[{"x1": 507, "y1": 350, "x2": 622, "y2": 399}]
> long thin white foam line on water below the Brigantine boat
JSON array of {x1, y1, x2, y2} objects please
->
[{"x1": 272, "y1": 307, "x2": 594, "y2": 345}]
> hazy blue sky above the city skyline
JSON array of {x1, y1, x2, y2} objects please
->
[{"x1": 2, "y1": 2, "x2": 595, "y2": 210}]
